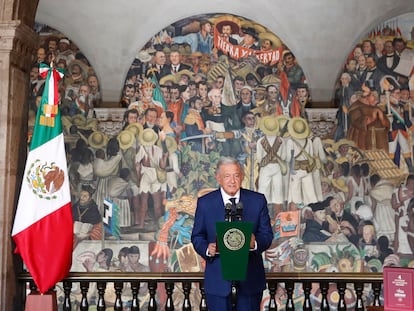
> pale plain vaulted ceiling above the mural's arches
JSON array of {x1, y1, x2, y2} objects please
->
[{"x1": 36, "y1": 0, "x2": 414, "y2": 102}]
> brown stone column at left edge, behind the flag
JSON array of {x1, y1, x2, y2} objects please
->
[{"x1": 0, "y1": 20, "x2": 38, "y2": 311}]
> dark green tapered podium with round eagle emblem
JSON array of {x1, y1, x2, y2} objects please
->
[{"x1": 216, "y1": 222, "x2": 253, "y2": 281}]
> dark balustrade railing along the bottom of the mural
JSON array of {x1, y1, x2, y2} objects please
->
[{"x1": 18, "y1": 272, "x2": 383, "y2": 311}]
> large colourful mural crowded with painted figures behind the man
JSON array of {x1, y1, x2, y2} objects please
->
[{"x1": 29, "y1": 14, "x2": 414, "y2": 310}]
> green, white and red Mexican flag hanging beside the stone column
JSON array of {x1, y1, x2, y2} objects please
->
[{"x1": 12, "y1": 64, "x2": 73, "y2": 293}]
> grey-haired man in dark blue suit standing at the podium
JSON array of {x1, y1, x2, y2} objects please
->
[{"x1": 191, "y1": 157, "x2": 273, "y2": 311}]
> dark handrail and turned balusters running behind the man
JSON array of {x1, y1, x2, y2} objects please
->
[{"x1": 17, "y1": 271, "x2": 383, "y2": 311}]
